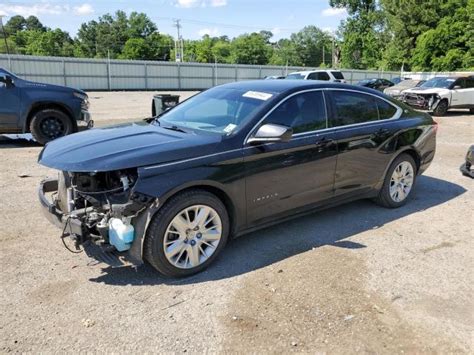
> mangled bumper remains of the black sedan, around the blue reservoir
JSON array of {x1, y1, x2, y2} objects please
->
[{"x1": 38, "y1": 179, "x2": 158, "y2": 267}]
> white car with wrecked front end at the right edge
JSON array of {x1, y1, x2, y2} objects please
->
[{"x1": 402, "y1": 76, "x2": 474, "y2": 116}]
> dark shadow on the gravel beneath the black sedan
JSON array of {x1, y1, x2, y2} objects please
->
[{"x1": 90, "y1": 176, "x2": 466, "y2": 286}]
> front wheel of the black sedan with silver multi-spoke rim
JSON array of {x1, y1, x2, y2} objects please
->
[{"x1": 144, "y1": 189, "x2": 229, "y2": 277}]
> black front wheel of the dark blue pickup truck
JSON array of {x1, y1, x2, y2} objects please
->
[{"x1": 30, "y1": 109, "x2": 74, "y2": 144}]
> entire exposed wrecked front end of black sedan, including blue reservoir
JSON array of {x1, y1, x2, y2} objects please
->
[{"x1": 39, "y1": 169, "x2": 158, "y2": 266}]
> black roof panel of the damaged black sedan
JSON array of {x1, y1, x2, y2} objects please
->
[{"x1": 215, "y1": 80, "x2": 385, "y2": 97}]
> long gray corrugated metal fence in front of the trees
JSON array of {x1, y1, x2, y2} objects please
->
[{"x1": 0, "y1": 54, "x2": 400, "y2": 90}]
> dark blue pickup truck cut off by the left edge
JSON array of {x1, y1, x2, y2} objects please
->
[{"x1": 0, "y1": 68, "x2": 94, "y2": 144}]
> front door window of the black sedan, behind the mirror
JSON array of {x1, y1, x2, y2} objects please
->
[{"x1": 263, "y1": 91, "x2": 327, "y2": 134}]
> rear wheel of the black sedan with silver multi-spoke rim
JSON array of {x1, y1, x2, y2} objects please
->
[{"x1": 375, "y1": 154, "x2": 416, "y2": 208}]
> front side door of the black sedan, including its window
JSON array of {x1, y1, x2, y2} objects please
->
[{"x1": 244, "y1": 90, "x2": 337, "y2": 226}]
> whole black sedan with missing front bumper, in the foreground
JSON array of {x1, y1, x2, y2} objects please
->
[{"x1": 39, "y1": 80, "x2": 437, "y2": 277}]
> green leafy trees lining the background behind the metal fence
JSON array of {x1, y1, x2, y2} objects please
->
[{"x1": 0, "y1": 0, "x2": 474, "y2": 71}]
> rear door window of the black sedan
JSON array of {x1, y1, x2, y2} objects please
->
[{"x1": 329, "y1": 91, "x2": 379, "y2": 127}]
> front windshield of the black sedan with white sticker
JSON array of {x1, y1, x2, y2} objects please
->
[{"x1": 158, "y1": 87, "x2": 274, "y2": 135}]
